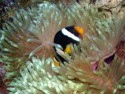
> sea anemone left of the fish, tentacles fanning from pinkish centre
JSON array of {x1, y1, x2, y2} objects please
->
[{"x1": 0, "y1": 2, "x2": 70, "y2": 79}]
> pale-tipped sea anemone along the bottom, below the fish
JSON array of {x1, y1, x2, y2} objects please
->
[{"x1": 8, "y1": 56, "x2": 125, "y2": 94}]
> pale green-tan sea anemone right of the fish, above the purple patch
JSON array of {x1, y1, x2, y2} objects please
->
[{"x1": 61, "y1": 3, "x2": 125, "y2": 62}]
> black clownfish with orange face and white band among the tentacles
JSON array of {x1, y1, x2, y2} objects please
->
[{"x1": 54, "y1": 26, "x2": 85, "y2": 66}]
